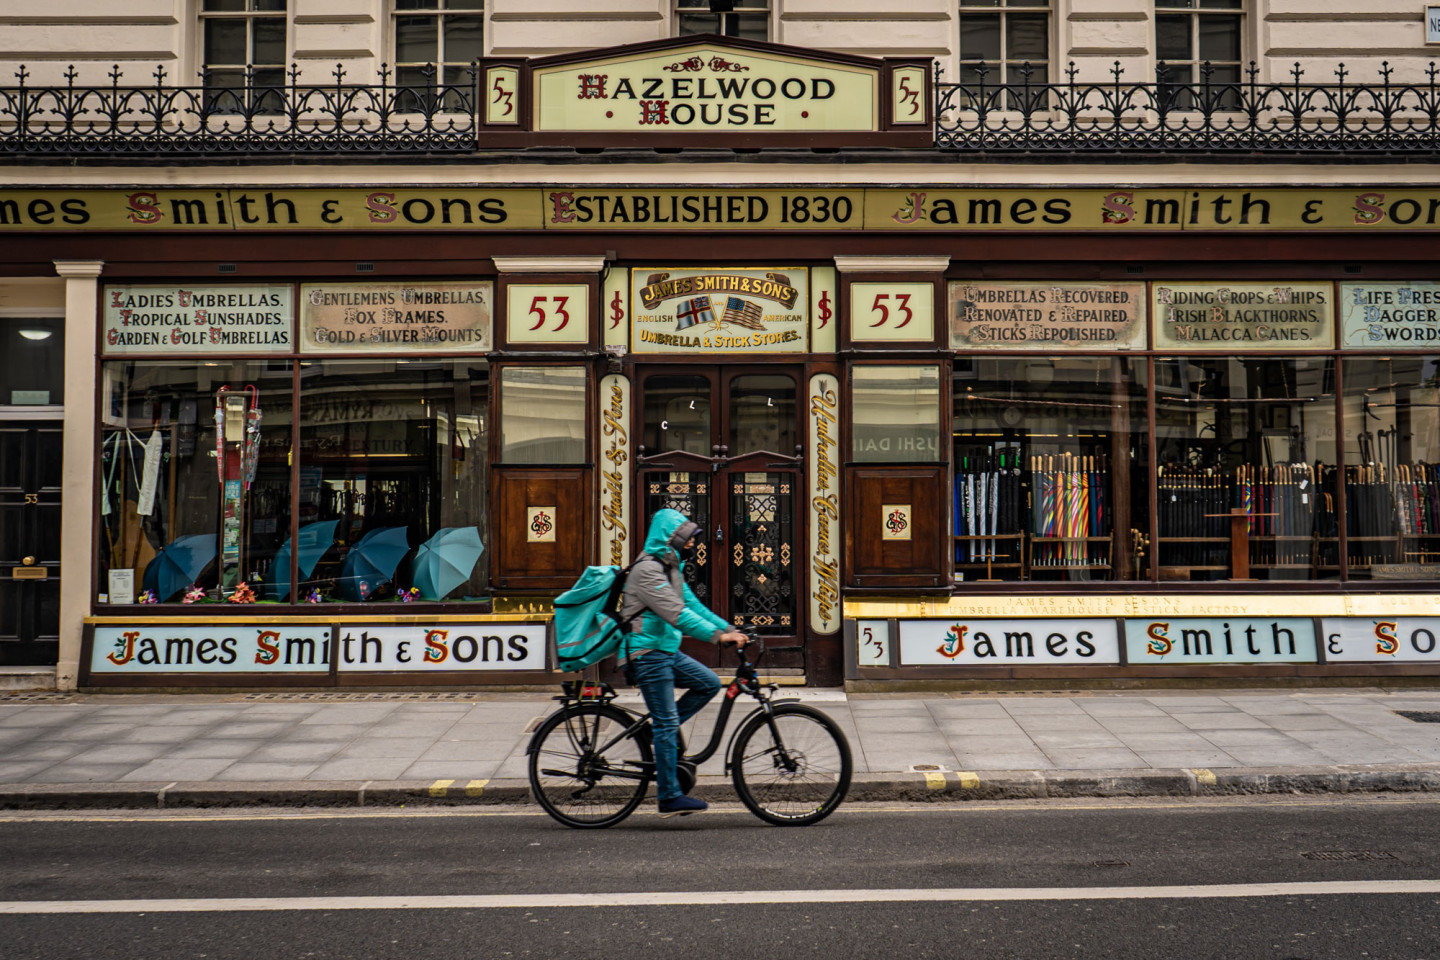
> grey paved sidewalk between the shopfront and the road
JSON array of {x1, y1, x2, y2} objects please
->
[{"x1": 0, "y1": 687, "x2": 1440, "y2": 809}]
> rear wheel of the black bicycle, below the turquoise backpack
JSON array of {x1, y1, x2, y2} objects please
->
[{"x1": 530, "y1": 704, "x2": 654, "y2": 828}]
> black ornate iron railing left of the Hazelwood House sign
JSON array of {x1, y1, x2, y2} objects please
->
[{"x1": 0, "y1": 65, "x2": 478, "y2": 157}]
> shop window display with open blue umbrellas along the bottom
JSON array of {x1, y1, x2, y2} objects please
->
[{"x1": 99, "y1": 360, "x2": 490, "y2": 604}]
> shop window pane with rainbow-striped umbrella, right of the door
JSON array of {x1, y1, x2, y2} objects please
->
[{"x1": 952, "y1": 356, "x2": 1149, "y2": 581}]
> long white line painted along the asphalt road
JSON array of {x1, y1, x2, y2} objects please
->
[{"x1": 0, "y1": 879, "x2": 1440, "y2": 915}]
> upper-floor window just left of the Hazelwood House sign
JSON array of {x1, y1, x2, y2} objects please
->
[{"x1": 393, "y1": 0, "x2": 485, "y2": 112}]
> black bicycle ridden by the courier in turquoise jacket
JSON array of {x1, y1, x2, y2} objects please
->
[{"x1": 526, "y1": 640, "x2": 851, "y2": 829}]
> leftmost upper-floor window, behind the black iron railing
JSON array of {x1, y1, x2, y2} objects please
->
[{"x1": 200, "y1": 0, "x2": 288, "y2": 114}]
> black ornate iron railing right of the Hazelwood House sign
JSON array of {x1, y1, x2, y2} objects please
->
[{"x1": 935, "y1": 60, "x2": 1440, "y2": 160}]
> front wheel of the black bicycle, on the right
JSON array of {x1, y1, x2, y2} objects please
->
[{"x1": 730, "y1": 704, "x2": 851, "y2": 826}]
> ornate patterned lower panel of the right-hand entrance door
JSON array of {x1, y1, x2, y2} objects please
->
[{"x1": 726, "y1": 472, "x2": 799, "y2": 636}]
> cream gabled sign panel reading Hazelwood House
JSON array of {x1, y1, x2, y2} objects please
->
[{"x1": 533, "y1": 43, "x2": 880, "y2": 134}]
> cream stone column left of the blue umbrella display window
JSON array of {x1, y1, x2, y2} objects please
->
[{"x1": 55, "y1": 261, "x2": 105, "y2": 691}]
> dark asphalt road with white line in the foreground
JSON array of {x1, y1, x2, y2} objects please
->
[{"x1": 0, "y1": 796, "x2": 1440, "y2": 960}]
